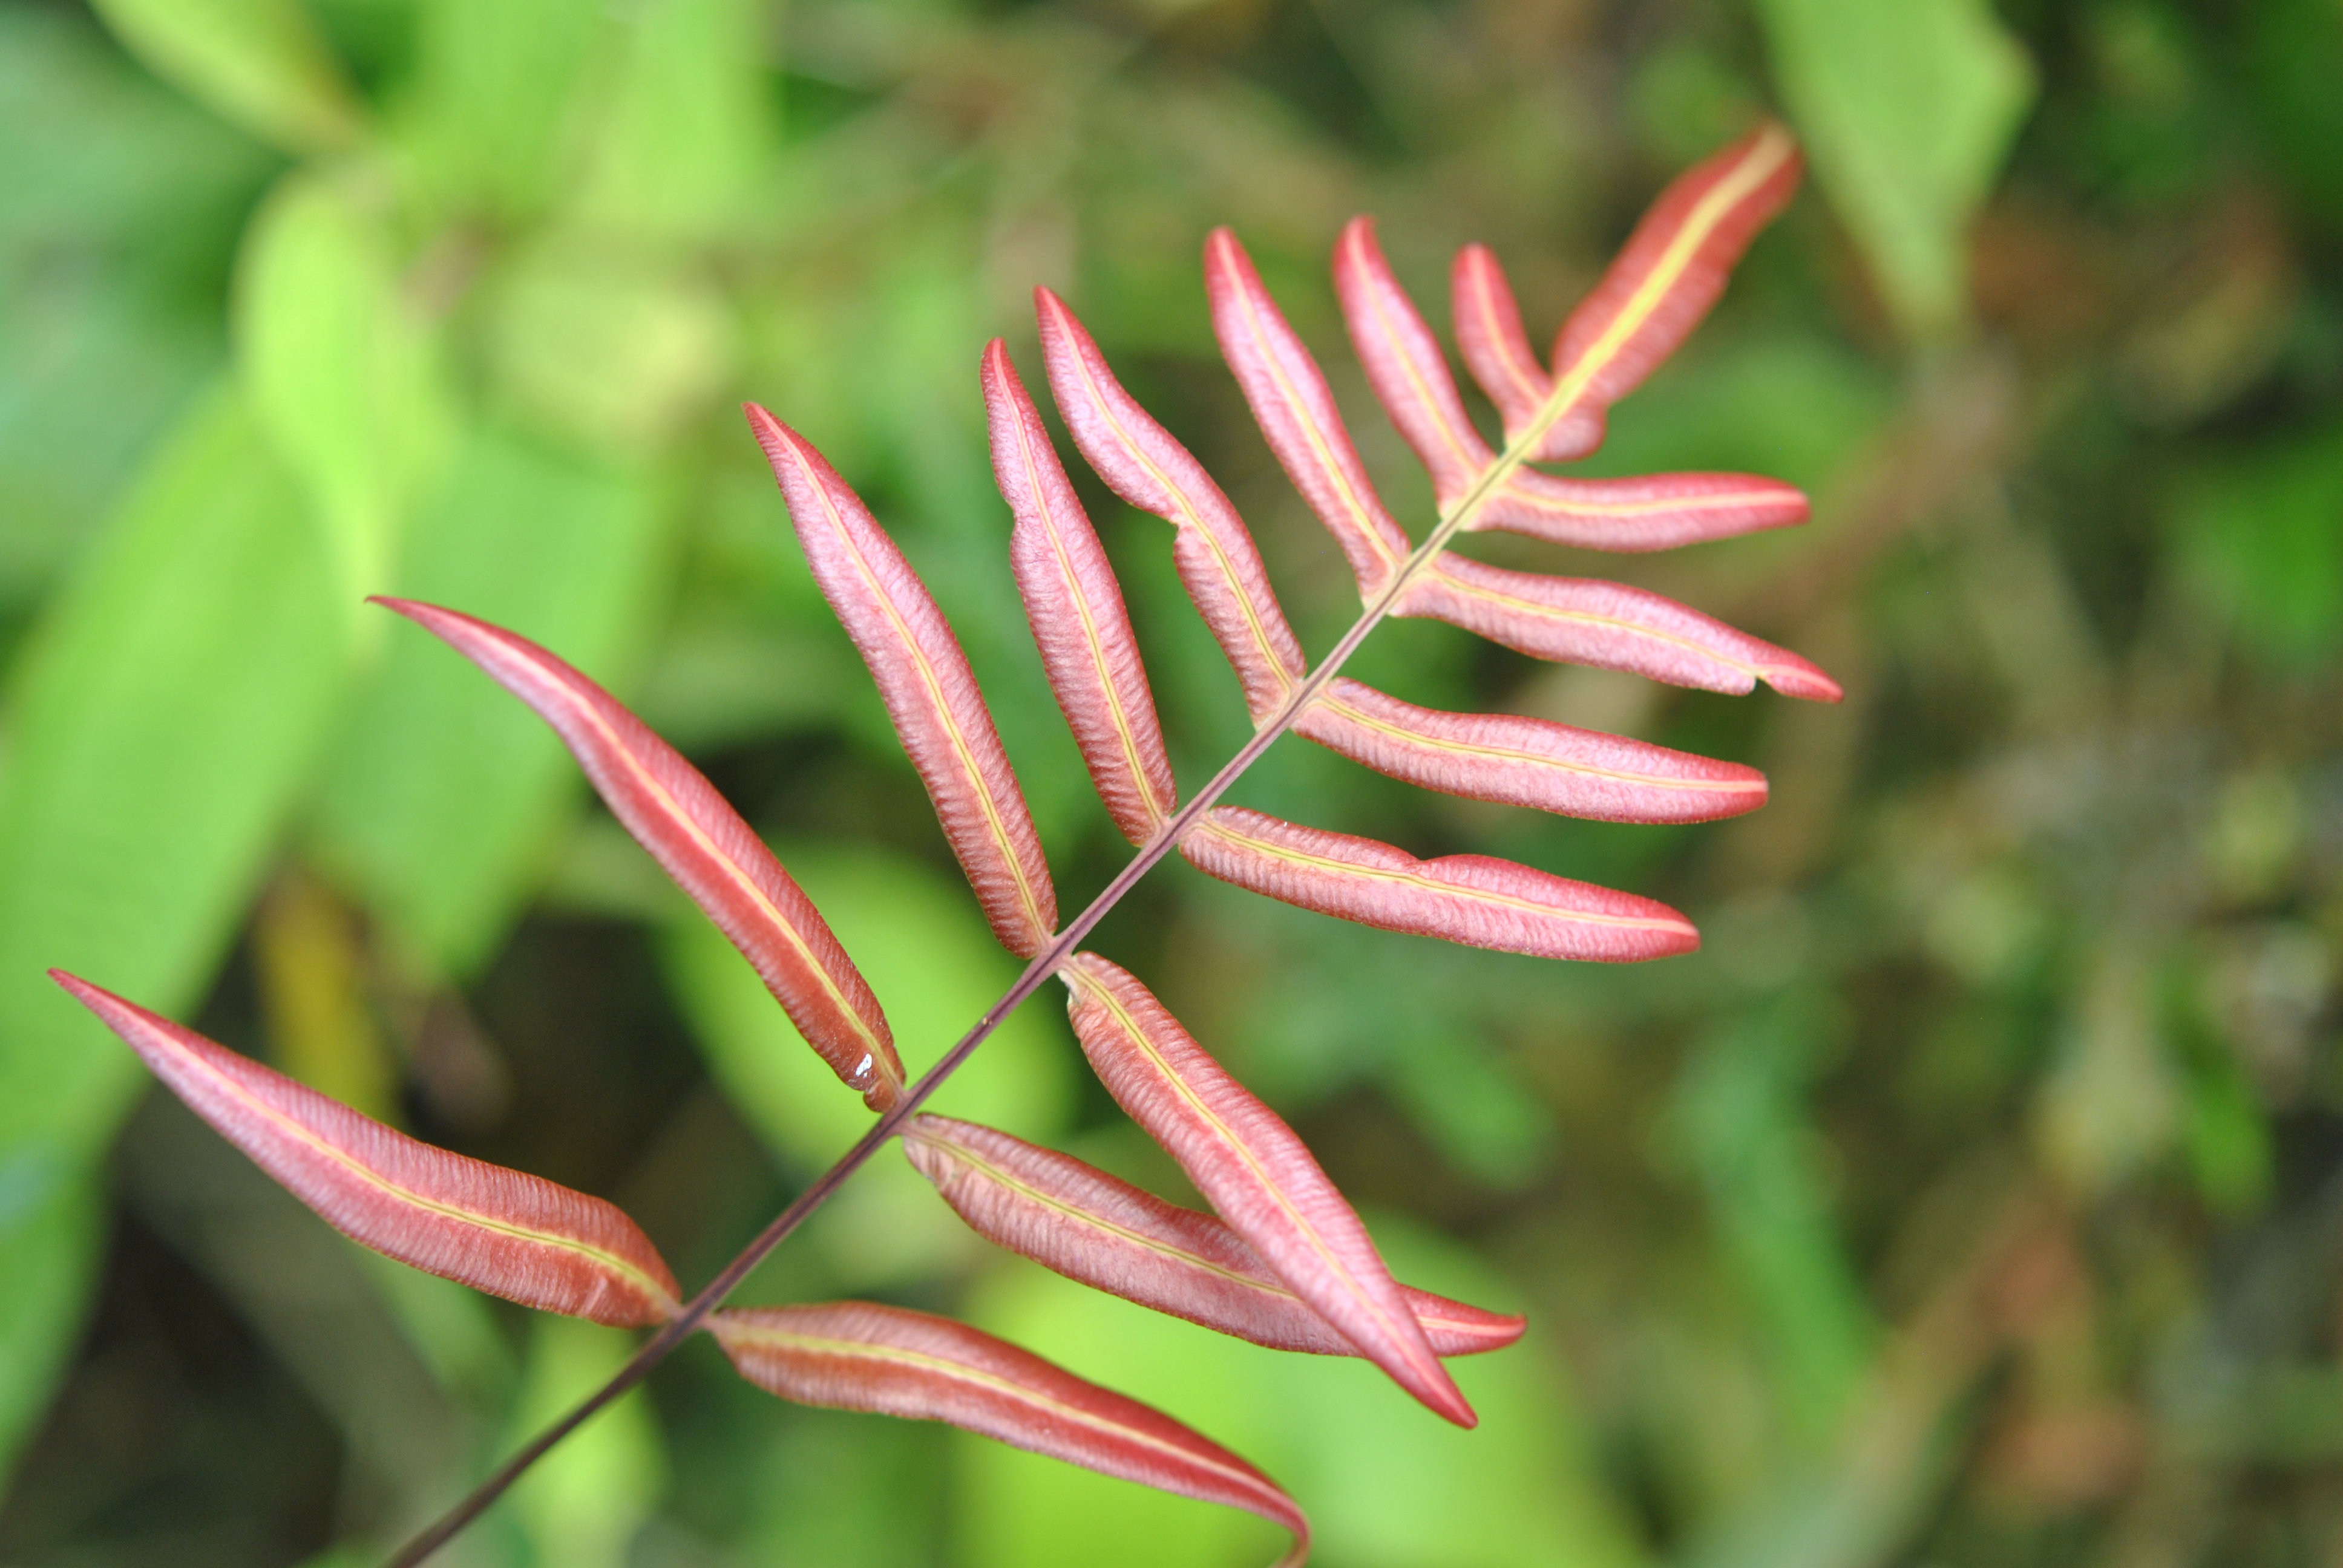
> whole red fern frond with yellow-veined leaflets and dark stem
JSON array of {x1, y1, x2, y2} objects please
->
[{"x1": 56, "y1": 124, "x2": 1840, "y2": 1568}]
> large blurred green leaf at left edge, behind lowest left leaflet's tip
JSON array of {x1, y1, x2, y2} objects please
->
[{"x1": 0, "y1": 394, "x2": 347, "y2": 1472}]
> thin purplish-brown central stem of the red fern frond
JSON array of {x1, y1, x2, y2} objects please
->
[{"x1": 384, "y1": 400, "x2": 1577, "y2": 1568}]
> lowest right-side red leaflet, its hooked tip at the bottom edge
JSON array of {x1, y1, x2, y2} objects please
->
[{"x1": 707, "y1": 1301, "x2": 1309, "y2": 1566}]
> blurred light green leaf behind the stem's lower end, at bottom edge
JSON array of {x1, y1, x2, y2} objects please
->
[{"x1": 506, "y1": 1313, "x2": 668, "y2": 1568}]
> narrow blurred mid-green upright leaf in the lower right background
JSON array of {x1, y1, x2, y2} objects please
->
[{"x1": 1675, "y1": 999, "x2": 1876, "y2": 1444}]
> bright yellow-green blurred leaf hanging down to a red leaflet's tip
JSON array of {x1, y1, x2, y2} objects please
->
[{"x1": 234, "y1": 174, "x2": 448, "y2": 605}]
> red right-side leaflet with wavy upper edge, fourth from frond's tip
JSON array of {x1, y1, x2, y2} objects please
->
[{"x1": 1181, "y1": 806, "x2": 1701, "y2": 963}]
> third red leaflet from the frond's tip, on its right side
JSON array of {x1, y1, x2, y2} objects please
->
[{"x1": 1293, "y1": 678, "x2": 1766, "y2": 823}]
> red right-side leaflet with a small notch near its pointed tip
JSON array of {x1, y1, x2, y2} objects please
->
[{"x1": 1392, "y1": 555, "x2": 1841, "y2": 703}]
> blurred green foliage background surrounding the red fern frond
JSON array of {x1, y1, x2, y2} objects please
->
[{"x1": 0, "y1": 0, "x2": 2343, "y2": 1568}]
